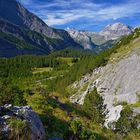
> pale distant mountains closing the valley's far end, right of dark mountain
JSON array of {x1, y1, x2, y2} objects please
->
[{"x1": 66, "y1": 23, "x2": 133, "y2": 51}]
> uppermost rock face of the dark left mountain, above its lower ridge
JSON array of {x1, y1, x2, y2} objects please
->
[{"x1": 0, "y1": 0, "x2": 58, "y2": 37}]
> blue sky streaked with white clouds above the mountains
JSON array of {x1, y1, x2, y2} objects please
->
[{"x1": 19, "y1": 0, "x2": 140, "y2": 31}]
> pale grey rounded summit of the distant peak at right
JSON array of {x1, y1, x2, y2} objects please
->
[{"x1": 99, "y1": 23, "x2": 133, "y2": 40}]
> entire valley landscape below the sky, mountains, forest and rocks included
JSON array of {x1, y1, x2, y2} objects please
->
[{"x1": 0, "y1": 0, "x2": 140, "y2": 140}]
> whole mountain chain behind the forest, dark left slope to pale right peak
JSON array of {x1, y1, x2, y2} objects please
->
[{"x1": 0, "y1": 0, "x2": 132, "y2": 57}]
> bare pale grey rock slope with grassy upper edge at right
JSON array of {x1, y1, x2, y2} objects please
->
[{"x1": 70, "y1": 38, "x2": 140, "y2": 126}]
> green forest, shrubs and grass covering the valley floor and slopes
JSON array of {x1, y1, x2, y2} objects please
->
[{"x1": 0, "y1": 29, "x2": 140, "y2": 140}]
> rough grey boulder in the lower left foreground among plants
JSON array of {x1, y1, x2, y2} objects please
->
[{"x1": 0, "y1": 104, "x2": 45, "y2": 140}]
